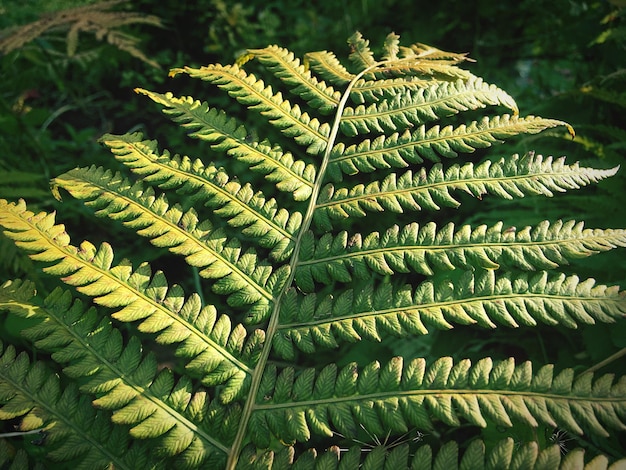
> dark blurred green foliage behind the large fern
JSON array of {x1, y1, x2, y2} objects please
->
[{"x1": 0, "y1": 0, "x2": 626, "y2": 455}]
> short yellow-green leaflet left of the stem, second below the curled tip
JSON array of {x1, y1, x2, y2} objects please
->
[{"x1": 248, "y1": 46, "x2": 341, "y2": 114}]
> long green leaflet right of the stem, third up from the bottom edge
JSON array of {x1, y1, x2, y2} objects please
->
[{"x1": 273, "y1": 271, "x2": 626, "y2": 359}]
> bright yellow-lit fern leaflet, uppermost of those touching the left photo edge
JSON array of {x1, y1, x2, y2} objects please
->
[{"x1": 0, "y1": 200, "x2": 264, "y2": 401}]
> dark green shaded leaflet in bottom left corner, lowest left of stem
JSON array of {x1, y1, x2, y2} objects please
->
[{"x1": 0, "y1": 345, "x2": 158, "y2": 470}]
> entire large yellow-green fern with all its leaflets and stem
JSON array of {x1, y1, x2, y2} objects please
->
[{"x1": 0, "y1": 33, "x2": 626, "y2": 469}]
